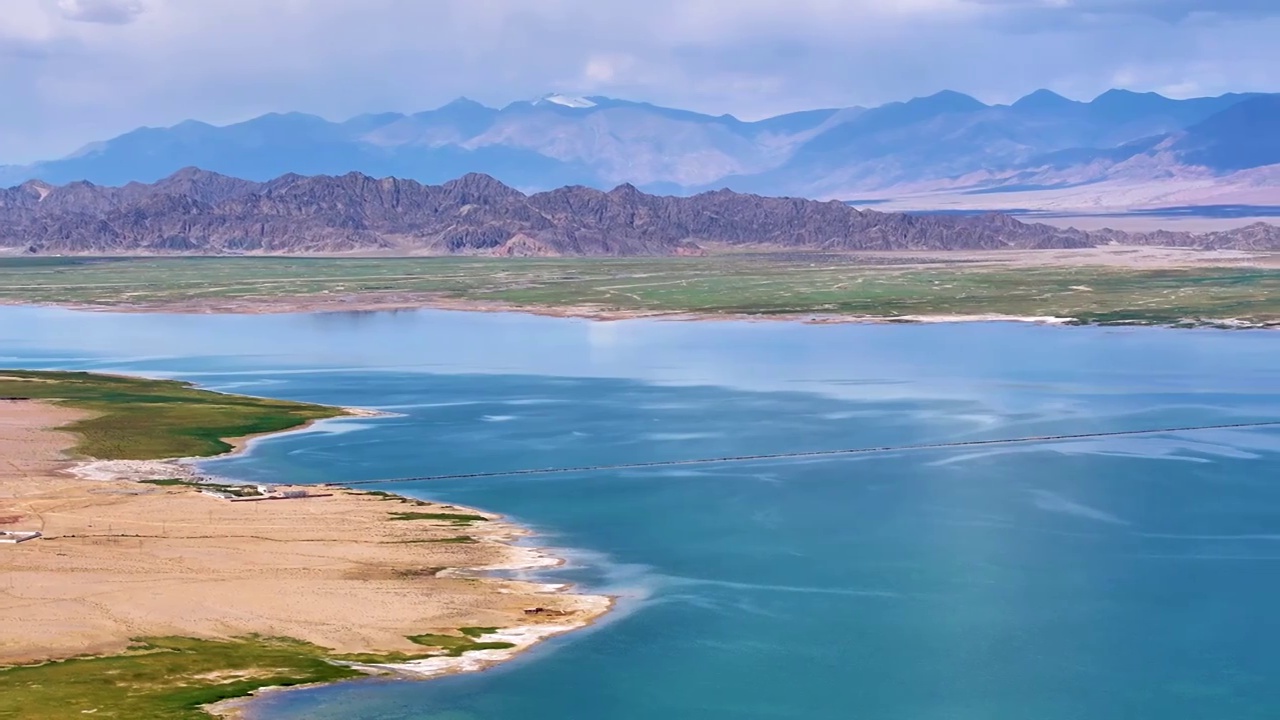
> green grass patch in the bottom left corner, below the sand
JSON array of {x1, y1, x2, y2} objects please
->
[{"x1": 0, "y1": 638, "x2": 361, "y2": 720}]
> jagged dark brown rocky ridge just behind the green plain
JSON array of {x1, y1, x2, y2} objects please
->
[{"x1": 0, "y1": 168, "x2": 1280, "y2": 256}]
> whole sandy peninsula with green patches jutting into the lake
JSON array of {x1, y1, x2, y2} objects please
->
[{"x1": 0, "y1": 370, "x2": 609, "y2": 720}]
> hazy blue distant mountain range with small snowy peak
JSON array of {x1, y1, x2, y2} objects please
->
[{"x1": 0, "y1": 90, "x2": 1280, "y2": 205}]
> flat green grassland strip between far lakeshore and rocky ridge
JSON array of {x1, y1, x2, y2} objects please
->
[{"x1": 0, "y1": 252, "x2": 1280, "y2": 324}]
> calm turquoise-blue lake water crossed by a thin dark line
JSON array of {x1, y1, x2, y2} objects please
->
[{"x1": 0, "y1": 309, "x2": 1280, "y2": 720}]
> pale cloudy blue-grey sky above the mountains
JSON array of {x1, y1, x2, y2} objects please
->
[{"x1": 0, "y1": 0, "x2": 1280, "y2": 164}]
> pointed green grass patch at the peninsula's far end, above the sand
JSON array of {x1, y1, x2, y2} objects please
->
[{"x1": 0, "y1": 370, "x2": 343, "y2": 460}]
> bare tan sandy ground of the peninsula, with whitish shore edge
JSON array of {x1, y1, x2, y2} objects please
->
[{"x1": 0, "y1": 401, "x2": 609, "y2": 712}]
